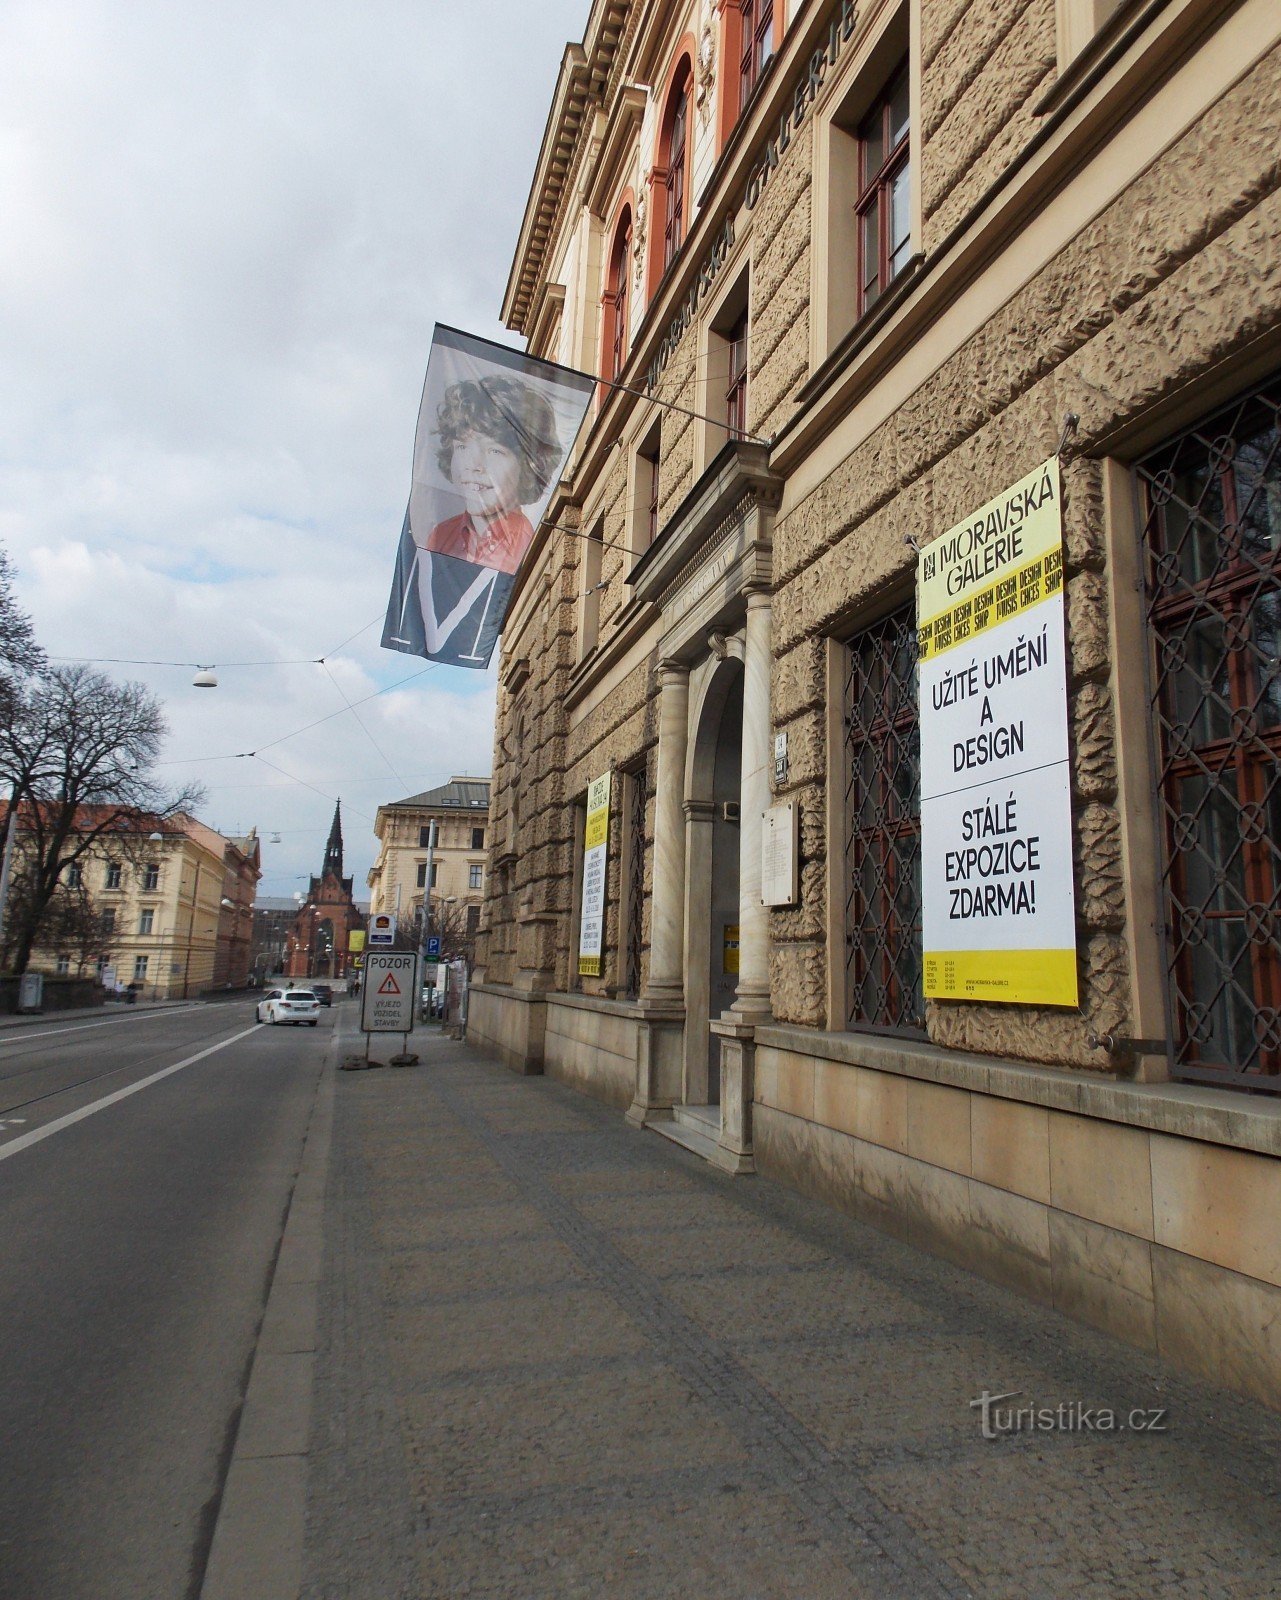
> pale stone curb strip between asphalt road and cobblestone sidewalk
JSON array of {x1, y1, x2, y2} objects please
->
[{"x1": 200, "y1": 1029, "x2": 342, "y2": 1600}]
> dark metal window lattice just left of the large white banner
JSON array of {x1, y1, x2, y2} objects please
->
[{"x1": 844, "y1": 605, "x2": 924, "y2": 1032}]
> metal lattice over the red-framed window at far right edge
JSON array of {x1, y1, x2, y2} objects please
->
[{"x1": 1139, "y1": 381, "x2": 1281, "y2": 1093}]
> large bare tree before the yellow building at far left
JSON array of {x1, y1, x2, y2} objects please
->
[{"x1": 0, "y1": 666, "x2": 203, "y2": 973}]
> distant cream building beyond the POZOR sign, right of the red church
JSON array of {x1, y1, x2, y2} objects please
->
[{"x1": 368, "y1": 778, "x2": 489, "y2": 950}]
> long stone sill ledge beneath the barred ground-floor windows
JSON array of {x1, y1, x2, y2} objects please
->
[{"x1": 756, "y1": 1022, "x2": 1281, "y2": 1155}]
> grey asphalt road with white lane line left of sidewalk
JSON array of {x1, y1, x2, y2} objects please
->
[{"x1": 0, "y1": 1000, "x2": 337, "y2": 1600}]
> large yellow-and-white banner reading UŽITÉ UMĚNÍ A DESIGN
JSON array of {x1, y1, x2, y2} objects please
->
[{"x1": 916, "y1": 456, "x2": 1078, "y2": 1006}]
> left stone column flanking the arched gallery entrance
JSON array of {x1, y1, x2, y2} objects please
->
[{"x1": 643, "y1": 661, "x2": 689, "y2": 1005}]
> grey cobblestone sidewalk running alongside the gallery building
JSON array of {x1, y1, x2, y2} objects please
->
[{"x1": 304, "y1": 1040, "x2": 1281, "y2": 1600}]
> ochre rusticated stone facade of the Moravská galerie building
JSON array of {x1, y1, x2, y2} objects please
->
[{"x1": 469, "y1": 0, "x2": 1281, "y2": 1403}]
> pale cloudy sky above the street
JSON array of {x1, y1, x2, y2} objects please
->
[{"x1": 0, "y1": 0, "x2": 589, "y2": 894}]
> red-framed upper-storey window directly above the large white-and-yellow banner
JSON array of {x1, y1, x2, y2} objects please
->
[{"x1": 856, "y1": 64, "x2": 912, "y2": 315}]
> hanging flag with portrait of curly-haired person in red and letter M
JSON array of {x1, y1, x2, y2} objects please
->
[{"x1": 382, "y1": 325, "x2": 595, "y2": 669}]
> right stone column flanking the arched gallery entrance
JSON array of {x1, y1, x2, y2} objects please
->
[{"x1": 732, "y1": 589, "x2": 772, "y2": 1018}]
